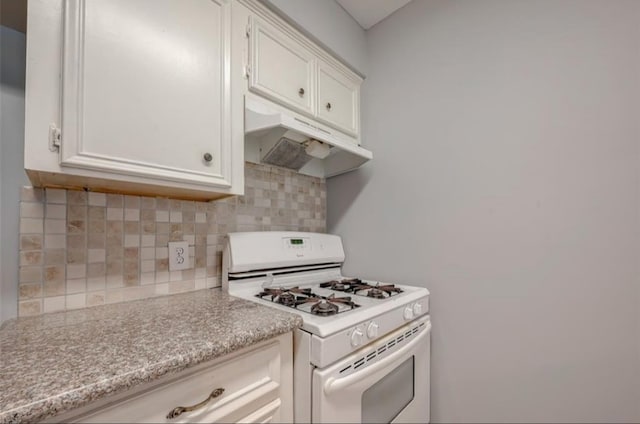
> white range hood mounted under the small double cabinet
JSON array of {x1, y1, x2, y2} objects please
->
[{"x1": 244, "y1": 96, "x2": 373, "y2": 178}]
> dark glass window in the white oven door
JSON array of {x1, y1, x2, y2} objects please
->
[{"x1": 362, "y1": 356, "x2": 414, "y2": 423}]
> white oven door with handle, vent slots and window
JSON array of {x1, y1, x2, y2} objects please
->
[{"x1": 311, "y1": 316, "x2": 431, "y2": 423}]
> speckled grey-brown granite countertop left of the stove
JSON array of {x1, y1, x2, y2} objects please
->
[{"x1": 0, "y1": 289, "x2": 302, "y2": 423}]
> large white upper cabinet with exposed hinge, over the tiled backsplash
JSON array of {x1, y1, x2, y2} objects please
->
[{"x1": 25, "y1": 0, "x2": 243, "y2": 199}]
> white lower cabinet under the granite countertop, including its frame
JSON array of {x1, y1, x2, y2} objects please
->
[{"x1": 52, "y1": 333, "x2": 293, "y2": 423}]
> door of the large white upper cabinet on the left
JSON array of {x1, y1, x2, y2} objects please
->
[{"x1": 60, "y1": 0, "x2": 232, "y2": 190}]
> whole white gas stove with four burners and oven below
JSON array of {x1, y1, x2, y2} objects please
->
[{"x1": 222, "y1": 232, "x2": 431, "y2": 422}]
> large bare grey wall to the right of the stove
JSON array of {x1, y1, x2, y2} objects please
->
[{"x1": 328, "y1": 0, "x2": 640, "y2": 422}]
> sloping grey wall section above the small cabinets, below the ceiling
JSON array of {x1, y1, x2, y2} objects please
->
[{"x1": 265, "y1": 0, "x2": 367, "y2": 75}]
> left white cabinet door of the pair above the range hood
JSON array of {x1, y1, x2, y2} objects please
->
[{"x1": 249, "y1": 16, "x2": 315, "y2": 115}]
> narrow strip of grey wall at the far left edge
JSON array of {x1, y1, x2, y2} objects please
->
[{"x1": 0, "y1": 26, "x2": 29, "y2": 321}]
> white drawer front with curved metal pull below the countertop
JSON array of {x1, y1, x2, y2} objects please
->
[{"x1": 72, "y1": 342, "x2": 281, "y2": 423}]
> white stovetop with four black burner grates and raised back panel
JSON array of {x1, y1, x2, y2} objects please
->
[{"x1": 222, "y1": 231, "x2": 429, "y2": 340}]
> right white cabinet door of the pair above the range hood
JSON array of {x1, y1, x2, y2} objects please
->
[{"x1": 317, "y1": 61, "x2": 360, "y2": 137}]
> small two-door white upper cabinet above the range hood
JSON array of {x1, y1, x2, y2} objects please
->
[{"x1": 241, "y1": 0, "x2": 362, "y2": 144}]
